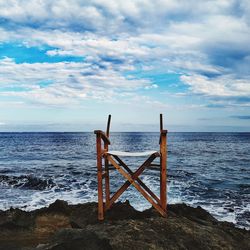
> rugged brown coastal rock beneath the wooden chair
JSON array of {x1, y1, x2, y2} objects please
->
[{"x1": 0, "y1": 200, "x2": 250, "y2": 250}]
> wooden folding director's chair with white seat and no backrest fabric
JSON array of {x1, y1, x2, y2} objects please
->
[{"x1": 94, "y1": 114, "x2": 167, "y2": 220}]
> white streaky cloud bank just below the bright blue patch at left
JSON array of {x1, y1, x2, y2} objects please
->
[{"x1": 0, "y1": 58, "x2": 156, "y2": 105}]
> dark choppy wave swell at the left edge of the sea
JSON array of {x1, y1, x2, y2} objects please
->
[{"x1": 0, "y1": 175, "x2": 56, "y2": 190}]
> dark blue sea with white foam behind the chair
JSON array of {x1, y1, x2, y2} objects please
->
[{"x1": 0, "y1": 133, "x2": 250, "y2": 228}]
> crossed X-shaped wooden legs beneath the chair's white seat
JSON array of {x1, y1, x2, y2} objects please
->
[{"x1": 104, "y1": 153, "x2": 166, "y2": 217}]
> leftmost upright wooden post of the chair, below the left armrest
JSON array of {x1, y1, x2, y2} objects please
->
[{"x1": 96, "y1": 133, "x2": 104, "y2": 220}]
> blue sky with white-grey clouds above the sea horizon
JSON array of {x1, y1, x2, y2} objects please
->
[{"x1": 0, "y1": 0, "x2": 250, "y2": 132}]
